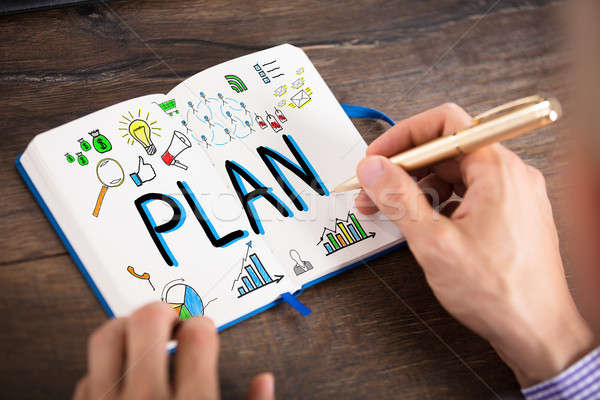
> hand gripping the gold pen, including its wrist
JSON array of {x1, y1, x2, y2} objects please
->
[{"x1": 356, "y1": 104, "x2": 594, "y2": 386}]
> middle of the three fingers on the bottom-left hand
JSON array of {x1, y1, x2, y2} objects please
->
[{"x1": 124, "y1": 302, "x2": 177, "y2": 398}]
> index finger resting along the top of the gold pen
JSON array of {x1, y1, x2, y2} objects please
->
[{"x1": 367, "y1": 103, "x2": 473, "y2": 157}]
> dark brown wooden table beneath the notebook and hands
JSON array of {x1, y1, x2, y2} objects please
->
[{"x1": 0, "y1": 0, "x2": 568, "y2": 399}]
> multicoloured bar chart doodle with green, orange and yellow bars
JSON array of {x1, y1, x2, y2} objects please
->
[{"x1": 317, "y1": 212, "x2": 375, "y2": 256}]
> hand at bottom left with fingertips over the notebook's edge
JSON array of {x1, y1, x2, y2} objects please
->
[{"x1": 73, "y1": 303, "x2": 275, "y2": 400}]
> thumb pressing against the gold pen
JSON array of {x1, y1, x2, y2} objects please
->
[{"x1": 357, "y1": 156, "x2": 449, "y2": 241}]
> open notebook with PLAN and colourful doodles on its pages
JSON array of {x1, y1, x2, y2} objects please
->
[{"x1": 17, "y1": 45, "x2": 403, "y2": 328}]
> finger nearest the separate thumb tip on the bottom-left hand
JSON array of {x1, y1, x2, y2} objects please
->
[{"x1": 175, "y1": 317, "x2": 219, "y2": 399}]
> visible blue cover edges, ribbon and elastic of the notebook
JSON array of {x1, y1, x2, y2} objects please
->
[{"x1": 15, "y1": 104, "x2": 406, "y2": 332}]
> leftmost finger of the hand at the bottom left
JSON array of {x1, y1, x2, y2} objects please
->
[{"x1": 88, "y1": 318, "x2": 127, "y2": 399}]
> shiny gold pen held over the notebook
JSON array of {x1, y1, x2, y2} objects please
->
[{"x1": 333, "y1": 95, "x2": 562, "y2": 192}]
